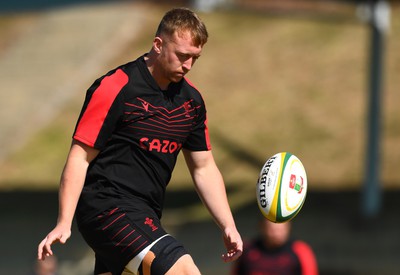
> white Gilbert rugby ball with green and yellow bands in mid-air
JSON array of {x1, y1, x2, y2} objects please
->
[{"x1": 256, "y1": 152, "x2": 307, "y2": 223}]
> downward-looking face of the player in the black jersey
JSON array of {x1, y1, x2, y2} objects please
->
[{"x1": 158, "y1": 29, "x2": 202, "y2": 84}]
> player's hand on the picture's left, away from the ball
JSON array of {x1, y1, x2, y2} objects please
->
[{"x1": 38, "y1": 225, "x2": 71, "y2": 260}]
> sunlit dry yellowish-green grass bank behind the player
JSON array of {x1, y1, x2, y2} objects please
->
[{"x1": 0, "y1": 4, "x2": 400, "y2": 190}]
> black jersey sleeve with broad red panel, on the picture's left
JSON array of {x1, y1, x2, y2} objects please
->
[{"x1": 73, "y1": 69, "x2": 128, "y2": 149}]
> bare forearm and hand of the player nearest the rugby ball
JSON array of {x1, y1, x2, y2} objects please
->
[{"x1": 183, "y1": 150, "x2": 243, "y2": 262}]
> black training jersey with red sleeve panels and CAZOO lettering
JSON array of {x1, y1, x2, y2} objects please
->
[{"x1": 73, "y1": 56, "x2": 211, "y2": 221}]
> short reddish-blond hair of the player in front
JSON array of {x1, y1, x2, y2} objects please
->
[{"x1": 156, "y1": 8, "x2": 208, "y2": 46}]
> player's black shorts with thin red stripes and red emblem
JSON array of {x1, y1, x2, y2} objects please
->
[{"x1": 80, "y1": 207, "x2": 168, "y2": 274}]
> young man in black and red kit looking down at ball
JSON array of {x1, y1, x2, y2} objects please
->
[{"x1": 38, "y1": 8, "x2": 243, "y2": 275}]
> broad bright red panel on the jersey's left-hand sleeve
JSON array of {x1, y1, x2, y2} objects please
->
[{"x1": 74, "y1": 69, "x2": 128, "y2": 147}]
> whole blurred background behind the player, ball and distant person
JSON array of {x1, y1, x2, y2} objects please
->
[{"x1": 0, "y1": 0, "x2": 400, "y2": 275}]
